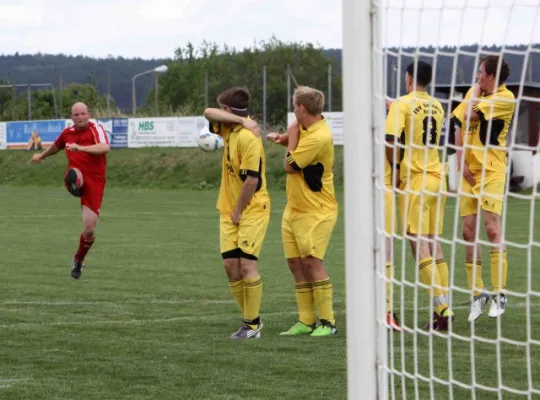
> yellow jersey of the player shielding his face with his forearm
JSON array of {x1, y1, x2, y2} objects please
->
[{"x1": 210, "y1": 123, "x2": 270, "y2": 215}]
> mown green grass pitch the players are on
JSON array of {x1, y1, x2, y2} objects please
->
[{"x1": 0, "y1": 186, "x2": 540, "y2": 400}]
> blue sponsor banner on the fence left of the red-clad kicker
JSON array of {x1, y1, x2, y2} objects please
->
[{"x1": 6, "y1": 119, "x2": 66, "y2": 149}]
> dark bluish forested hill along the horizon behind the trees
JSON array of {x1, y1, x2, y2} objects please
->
[{"x1": 0, "y1": 45, "x2": 540, "y2": 112}]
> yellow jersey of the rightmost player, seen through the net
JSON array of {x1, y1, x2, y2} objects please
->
[{"x1": 451, "y1": 85, "x2": 516, "y2": 174}]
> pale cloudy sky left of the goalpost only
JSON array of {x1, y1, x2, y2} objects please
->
[{"x1": 0, "y1": 0, "x2": 341, "y2": 58}]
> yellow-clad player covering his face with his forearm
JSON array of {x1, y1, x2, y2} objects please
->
[{"x1": 204, "y1": 87, "x2": 270, "y2": 339}]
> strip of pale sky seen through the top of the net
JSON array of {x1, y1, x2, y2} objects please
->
[{"x1": 384, "y1": 0, "x2": 540, "y2": 46}]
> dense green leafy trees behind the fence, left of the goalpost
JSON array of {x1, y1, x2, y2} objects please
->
[{"x1": 156, "y1": 38, "x2": 341, "y2": 124}]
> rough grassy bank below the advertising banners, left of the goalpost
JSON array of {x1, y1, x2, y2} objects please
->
[{"x1": 0, "y1": 146, "x2": 343, "y2": 189}]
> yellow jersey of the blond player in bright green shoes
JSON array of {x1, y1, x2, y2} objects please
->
[{"x1": 286, "y1": 117, "x2": 338, "y2": 213}]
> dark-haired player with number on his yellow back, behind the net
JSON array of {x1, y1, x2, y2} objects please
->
[{"x1": 386, "y1": 61, "x2": 453, "y2": 331}]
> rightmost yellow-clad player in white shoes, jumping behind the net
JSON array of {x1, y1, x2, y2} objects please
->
[{"x1": 452, "y1": 56, "x2": 515, "y2": 321}]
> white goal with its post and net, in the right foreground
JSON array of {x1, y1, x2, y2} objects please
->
[{"x1": 343, "y1": 0, "x2": 540, "y2": 399}]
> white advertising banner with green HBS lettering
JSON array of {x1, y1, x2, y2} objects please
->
[{"x1": 128, "y1": 117, "x2": 179, "y2": 147}]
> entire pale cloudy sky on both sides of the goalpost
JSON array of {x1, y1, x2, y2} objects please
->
[{"x1": 0, "y1": 0, "x2": 540, "y2": 58}]
